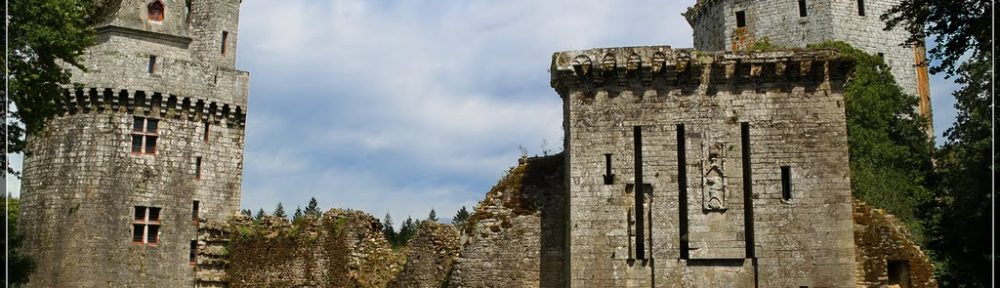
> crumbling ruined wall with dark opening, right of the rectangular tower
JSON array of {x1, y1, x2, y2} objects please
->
[{"x1": 854, "y1": 200, "x2": 938, "y2": 288}]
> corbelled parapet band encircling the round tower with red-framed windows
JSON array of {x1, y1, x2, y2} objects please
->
[{"x1": 56, "y1": 88, "x2": 246, "y2": 128}]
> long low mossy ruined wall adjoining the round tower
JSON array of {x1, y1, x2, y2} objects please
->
[{"x1": 225, "y1": 209, "x2": 405, "y2": 287}]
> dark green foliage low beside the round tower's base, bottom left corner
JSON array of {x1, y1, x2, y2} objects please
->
[{"x1": 0, "y1": 195, "x2": 35, "y2": 287}]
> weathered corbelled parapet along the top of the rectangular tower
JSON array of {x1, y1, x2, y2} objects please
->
[{"x1": 551, "y1": 46, "x2": 854, "y2": 97}]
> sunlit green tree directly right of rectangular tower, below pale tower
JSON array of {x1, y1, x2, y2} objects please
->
[{"x1": 812, "y1": 42, "x2": 933, "y2": 243}]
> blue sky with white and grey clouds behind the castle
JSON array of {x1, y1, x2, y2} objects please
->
[{"x1": 7, "y1": 0, "x2": 956, "y2": 225}]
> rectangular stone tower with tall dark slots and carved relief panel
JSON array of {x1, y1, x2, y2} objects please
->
[{"x1": 550, "y1": 46, "x2": 855, "y2": 287}]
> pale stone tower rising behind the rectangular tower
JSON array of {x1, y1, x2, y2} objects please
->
[{"x1": 684, "y1": 0, "x2": 933, "y2": 135}]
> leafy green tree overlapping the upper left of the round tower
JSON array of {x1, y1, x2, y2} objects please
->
[{"x1": 3, "y1": 0, "x2": 96, "y2": 172}]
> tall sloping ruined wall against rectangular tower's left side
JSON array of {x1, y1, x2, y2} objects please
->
[{"x1": 449, "y1": 154, "x2": 568, "y2": 287}]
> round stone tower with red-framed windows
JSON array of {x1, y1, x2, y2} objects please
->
[{"x1": 20, "y1": 0, "x2": 249, "y2": 287}]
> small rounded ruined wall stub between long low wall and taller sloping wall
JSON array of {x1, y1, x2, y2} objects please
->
[{"x1": 387, "y1": 221, "x2": 462, "y2": 288}]
